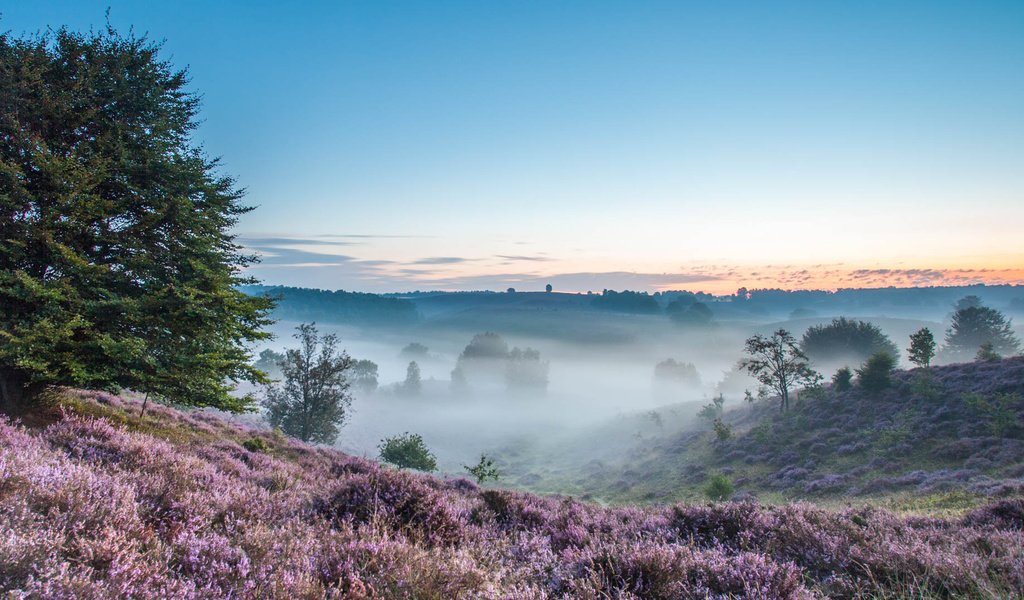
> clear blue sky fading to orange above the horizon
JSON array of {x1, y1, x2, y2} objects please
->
[{"x1": 8, "y1": 0, "x2": 1024, "y2": 293}]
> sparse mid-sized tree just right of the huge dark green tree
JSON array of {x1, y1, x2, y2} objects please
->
[{"x1": 263, "y1": 324, "x2": 353, "y2": 443}]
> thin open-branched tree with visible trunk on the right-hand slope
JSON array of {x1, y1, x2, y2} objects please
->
[{"x1": 739, "y1": 329, "x2": 821, "y2": 412}]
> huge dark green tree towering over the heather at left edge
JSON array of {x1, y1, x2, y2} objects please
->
[{"x1": 0, "y1": 29, "x2": 272, "y2": 412}]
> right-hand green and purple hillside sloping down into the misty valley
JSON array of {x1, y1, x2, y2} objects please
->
[{"x1": 507, "y1": 357, "x2": 1024, "y2": 506}]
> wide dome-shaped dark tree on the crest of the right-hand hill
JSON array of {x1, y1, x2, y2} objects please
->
[{"x1": 800, "y1": 316, "x2": 897, "y2": 365}]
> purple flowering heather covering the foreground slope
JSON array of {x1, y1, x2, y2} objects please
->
[{"x1": 0, "y1": 392, "x2": 1024, "y2": 599}]
